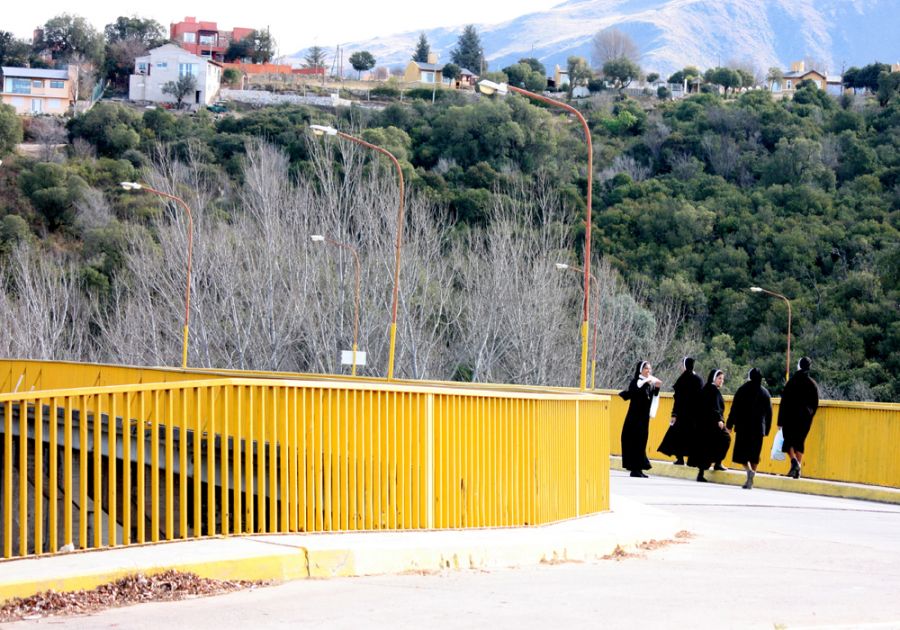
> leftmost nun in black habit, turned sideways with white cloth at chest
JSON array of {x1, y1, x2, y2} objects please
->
[{"x1": 619, "y1": 361, "x2": 662, "y2": 477}]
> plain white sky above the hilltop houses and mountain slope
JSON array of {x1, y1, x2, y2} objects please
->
[{"x1": 7, "y1": 0, "x2": 563, "y2": 55}]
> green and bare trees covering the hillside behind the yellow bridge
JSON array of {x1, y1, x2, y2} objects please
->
[{"x1": 0, "y1": 79, "x2": 900, "y2": 401}]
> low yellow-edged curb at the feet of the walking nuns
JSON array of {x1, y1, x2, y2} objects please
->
[{"x1": 609, "y1": 455, "x2": 900, "y2": 504}]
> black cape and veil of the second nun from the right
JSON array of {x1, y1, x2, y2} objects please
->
[{"x1": 726, "y1": 368, "x2": 772, "y2": 464}]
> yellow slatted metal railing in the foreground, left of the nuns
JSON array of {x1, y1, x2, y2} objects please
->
[{"x1": 0, "y1": 366, "x2": 609, "y2": 558}]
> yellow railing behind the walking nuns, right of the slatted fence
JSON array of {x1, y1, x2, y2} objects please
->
[{"x1": 604, "y1": 391, "x2": 900, "y2": 488}]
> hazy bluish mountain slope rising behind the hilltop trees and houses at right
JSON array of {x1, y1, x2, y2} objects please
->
[{"x1": 295, "y1": 0, "x2": 900, "y2": 75}]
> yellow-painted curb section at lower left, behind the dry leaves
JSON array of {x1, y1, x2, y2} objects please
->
[{"x1": 0, "y1": 548, "x2": 311, "y2": 604}]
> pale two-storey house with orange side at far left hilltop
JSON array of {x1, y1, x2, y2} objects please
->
[{"x1": 0, "y1": 66, "x2": 76, "y2": 115}]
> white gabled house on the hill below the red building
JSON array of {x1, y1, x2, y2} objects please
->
[{"x1": 128, "y1": 44, "x2": 222, "y2": 105}]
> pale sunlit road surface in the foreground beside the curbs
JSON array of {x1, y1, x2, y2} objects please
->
[{"x1": 12, "y1": 471, "x2": 900, "y2": 630}]
